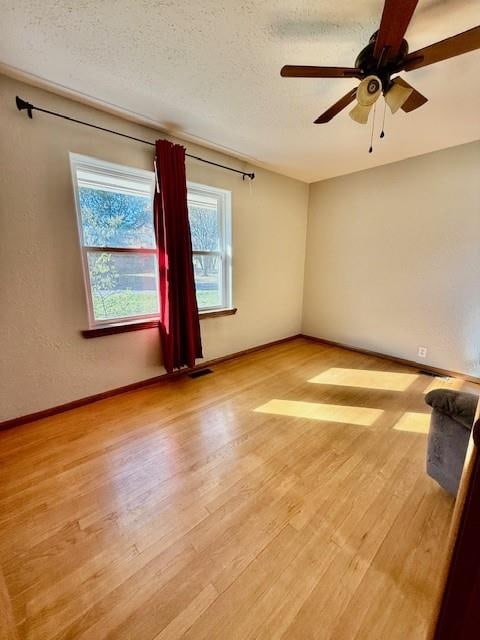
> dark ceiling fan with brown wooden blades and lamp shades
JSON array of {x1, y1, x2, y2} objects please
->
[{"x1": 280, "y1": 0, "x2": 480, "y2": 124}]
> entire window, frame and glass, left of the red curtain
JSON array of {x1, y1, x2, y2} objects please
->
[{"x1": 70, "y1": 154, "x2": 159, "y2": 327}]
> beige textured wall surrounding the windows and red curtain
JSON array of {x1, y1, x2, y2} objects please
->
[{"x1": 0, "y1": 76, "x2": 308, "y2": 421}]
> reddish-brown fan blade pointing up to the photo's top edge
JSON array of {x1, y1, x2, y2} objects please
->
[{"x1": 373, "y1": 0, "x2": 418, "y2": 63}]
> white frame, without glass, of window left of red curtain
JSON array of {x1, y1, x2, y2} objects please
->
[{"x1": 69, "y1": 152, "x2": 160, "y2": 330}]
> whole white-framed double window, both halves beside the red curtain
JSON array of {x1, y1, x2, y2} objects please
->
[{"x1": 70, "y1": 153, "x2": 232, "y2": 328}]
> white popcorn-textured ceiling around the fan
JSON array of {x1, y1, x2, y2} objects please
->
[{"x1": 0, "y1": 0, "x2": 480, "y2": 182}]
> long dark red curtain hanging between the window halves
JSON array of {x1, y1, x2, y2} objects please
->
[{"x1": 153, "y1": 140, "x2": 203, "y2": 373}]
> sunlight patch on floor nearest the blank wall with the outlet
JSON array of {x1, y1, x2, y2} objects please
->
[{"x1": 308, "y1": 367, "x2": 418, "y2": 391}]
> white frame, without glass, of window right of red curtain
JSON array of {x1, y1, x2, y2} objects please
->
[{"x1": 187, "y1": 181, "x2": 232, "y2": 315}]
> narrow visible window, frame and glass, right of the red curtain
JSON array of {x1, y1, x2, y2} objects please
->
[{"x1": 188, "y1": 182, "x2": 232, "y2": 311}]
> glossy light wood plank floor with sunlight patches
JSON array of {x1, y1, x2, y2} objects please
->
[{"x1": 0, "y1": 339, "x2": 478, "y2": 640}]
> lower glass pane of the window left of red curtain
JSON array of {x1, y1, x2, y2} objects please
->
[{"x1": 88, "y1": 251, "x2": 159, "y2": 320}]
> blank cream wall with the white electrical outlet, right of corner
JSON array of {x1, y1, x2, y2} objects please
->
[{"x1": 303, "y1": 142, "x2": 480, "y2": 376}]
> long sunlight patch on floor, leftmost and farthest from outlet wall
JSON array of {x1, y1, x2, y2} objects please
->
[{"x1": 254, "y1": 399, "x2": 383, "y2": 427}]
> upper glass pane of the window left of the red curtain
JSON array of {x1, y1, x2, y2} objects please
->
[{"x1": 78, "y1": 186, "x2": 155, "y2": 249}]
